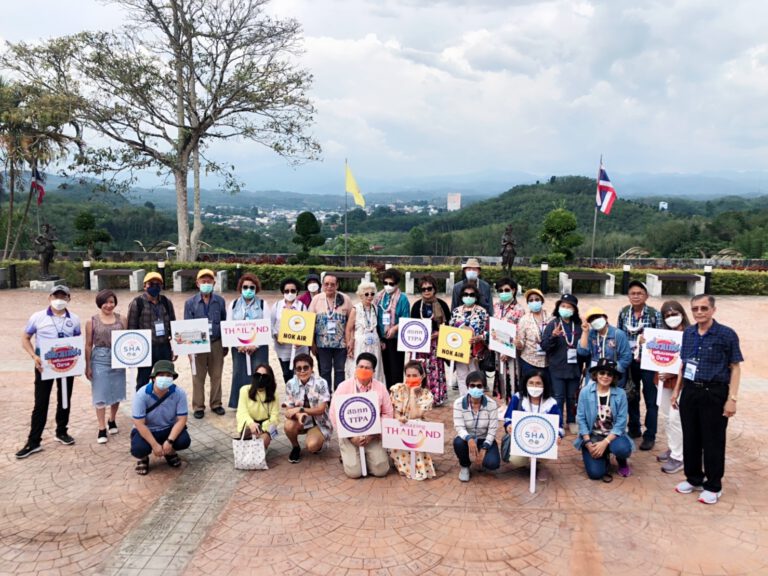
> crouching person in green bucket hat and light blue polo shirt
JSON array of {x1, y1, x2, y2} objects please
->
[{"x1": 131, "y1": 360, "x2": 192, "y2": 476}]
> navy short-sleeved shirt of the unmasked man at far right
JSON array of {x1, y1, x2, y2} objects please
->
[{"x1": 680, "y1": 320, "x2": 744, "y2": 384}]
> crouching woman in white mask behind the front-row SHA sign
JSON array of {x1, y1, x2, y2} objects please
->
[{"x1": 501, "y1": 370, "x2": 564, "y2": 480}]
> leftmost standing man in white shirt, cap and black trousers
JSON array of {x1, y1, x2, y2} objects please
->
[{"x1": 16, "y1": 285, "x2": 80, "y2": 459}]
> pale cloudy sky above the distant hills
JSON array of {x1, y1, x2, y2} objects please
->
[{"x1": 0, "y1": 0, "x2": 768, "y2": 190}]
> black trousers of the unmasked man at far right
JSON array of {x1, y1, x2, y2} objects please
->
[{"x1": 680, "y1": 380, "x2": 728, "y2": 492}]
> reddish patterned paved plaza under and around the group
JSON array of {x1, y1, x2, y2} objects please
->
[{"x1": 0, "y1": 290, "x2": 768, "y2": 576}]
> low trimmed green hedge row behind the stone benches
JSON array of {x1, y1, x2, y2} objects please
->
[{"x1": 3, "y1": 260, "x2": 768, "y2": 296}]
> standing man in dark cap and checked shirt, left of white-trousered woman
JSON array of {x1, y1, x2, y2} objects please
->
[{"x1": 616, "y1": 280, "x2": 665, "y2": 450}]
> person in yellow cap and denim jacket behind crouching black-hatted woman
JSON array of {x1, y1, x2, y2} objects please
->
[{"x1": 577, "y1": 306, "x2": 632, "y2": 389}]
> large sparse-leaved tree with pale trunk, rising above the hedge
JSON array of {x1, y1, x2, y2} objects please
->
[{"x1": 4, "y1": 0, "x2": 320, "y2": 260}]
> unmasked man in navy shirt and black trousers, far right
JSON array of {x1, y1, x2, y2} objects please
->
[{"x1": 672, "y1": 294, "x2": 744, "y2": 504}]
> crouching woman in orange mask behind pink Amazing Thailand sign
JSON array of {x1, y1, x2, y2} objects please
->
[{"x1": 389, "y1": 360, "x2": 435, "y2": 480}]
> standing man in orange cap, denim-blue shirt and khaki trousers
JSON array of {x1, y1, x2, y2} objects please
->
[{"x1": 184, "y1": 268, "x2": 229, "y2": 418}]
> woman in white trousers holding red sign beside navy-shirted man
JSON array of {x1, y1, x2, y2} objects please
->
[{"x1": 656, "y1": 300, "x2": 691, "y2": 474}]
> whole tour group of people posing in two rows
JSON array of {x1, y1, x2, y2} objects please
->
[{"x1": 16, "y1": 259, "x2": 743, "y2": 504}]
